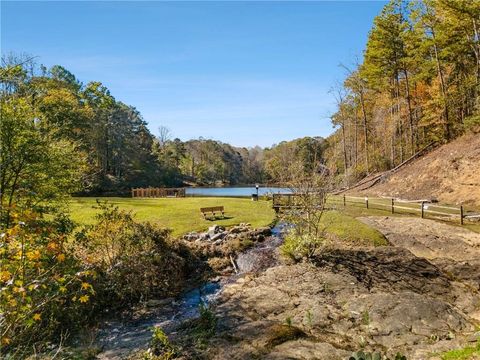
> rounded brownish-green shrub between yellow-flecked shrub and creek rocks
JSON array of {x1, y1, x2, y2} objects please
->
[{"x1": 76, "y1": 204, "x2": 198, "y2": 308}]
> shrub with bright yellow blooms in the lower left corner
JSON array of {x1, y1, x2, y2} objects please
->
[{"x1": 0, "y1": 211, "x2": 95, "y2": 356}]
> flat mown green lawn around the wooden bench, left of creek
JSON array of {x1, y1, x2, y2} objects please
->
[{"x1": 70, "y1": 197, "x2": 275, "y2": 236}]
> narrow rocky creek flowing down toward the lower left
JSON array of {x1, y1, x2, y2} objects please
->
[{"x1": 96, "y1": 223, "x2": 287, "y2": 359}]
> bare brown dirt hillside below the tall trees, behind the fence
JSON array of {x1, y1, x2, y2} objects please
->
[{"x1": 349, "y1": 134, "x2": 480, "y2": 207}]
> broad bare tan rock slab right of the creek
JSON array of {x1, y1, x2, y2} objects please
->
[{"x1": 203, "y1": 218, "x2": 480, "y2": 360}]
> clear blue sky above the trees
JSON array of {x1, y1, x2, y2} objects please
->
[{"x1": 1, "y1": 1, "x2": 385, "y2": 146}]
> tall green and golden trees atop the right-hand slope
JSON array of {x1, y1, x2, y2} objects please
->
[{"x1": 325, "y1": 0, "x2": 480, "y2": 185}]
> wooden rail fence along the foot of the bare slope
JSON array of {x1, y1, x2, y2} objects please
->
[{"x1": 327, "y1": 195, "x2": 478, "y2": 225}]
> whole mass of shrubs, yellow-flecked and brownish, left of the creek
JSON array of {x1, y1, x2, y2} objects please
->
[{"x1": 0, "y1": 205, "x2": 201, "y2": 358}]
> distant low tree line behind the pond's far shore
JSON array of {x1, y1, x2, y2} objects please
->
[{"x1": 155, "y1": 129, "x2": 324, "y2": 185}]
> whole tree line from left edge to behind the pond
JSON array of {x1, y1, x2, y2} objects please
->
[{"x1": 0, "y1": 55, "x2": 324, "y2": 218}]
